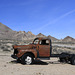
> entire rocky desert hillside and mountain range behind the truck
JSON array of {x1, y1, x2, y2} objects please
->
[{"x1": 0, "y1": 23, "x2": 75, "y2": 54}]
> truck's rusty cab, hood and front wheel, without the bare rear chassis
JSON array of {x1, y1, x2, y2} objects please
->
[{"x1": 12, "y1": 37, "x2": 52, "y2": 64}]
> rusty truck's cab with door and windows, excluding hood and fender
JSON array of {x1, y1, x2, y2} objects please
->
[{"x1": 33, "y1": 38, "x2": 51, "y2": 58}]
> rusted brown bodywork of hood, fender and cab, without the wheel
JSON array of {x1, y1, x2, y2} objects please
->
[{"x1": 13, "y1": 38, "x2": 51, "y2": 58}]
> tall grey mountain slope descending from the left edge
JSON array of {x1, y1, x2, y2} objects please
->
[{"x1": 0, "y1": 23, "x2": 14, "y2": 39}]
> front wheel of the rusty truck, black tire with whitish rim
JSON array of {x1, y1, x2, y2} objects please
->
[{"x1": 21, "y1": 53, "x2": 34, "y2": 65}]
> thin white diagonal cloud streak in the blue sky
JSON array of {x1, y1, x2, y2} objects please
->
[{"x1": 36, "y1": 9, "x2": 75, "y2": 32}]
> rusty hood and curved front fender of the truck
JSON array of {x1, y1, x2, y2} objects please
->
[{"x1": 13, "y1": 44, "x2": 37, "y2": 58}]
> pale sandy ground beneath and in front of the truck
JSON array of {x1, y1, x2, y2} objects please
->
[{"x1": 0, "y1": 52, "x2": 75, "y2": 75}]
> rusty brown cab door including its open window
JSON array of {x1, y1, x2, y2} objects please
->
[{"x1": 39, "y1": 40, "x2": 50, "y2": 57}]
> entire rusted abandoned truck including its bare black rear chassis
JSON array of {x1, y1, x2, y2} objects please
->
[{"x1": 11, "y1": 37, "x2": 75, "y2": 65}]
